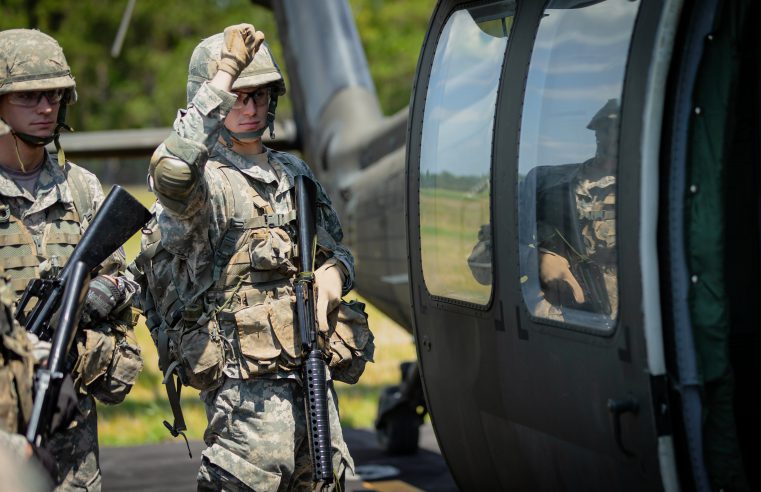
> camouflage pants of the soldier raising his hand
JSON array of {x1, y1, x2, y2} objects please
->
[{"x1": 198, "y1": 378, "x2": 354, "y2": 491}]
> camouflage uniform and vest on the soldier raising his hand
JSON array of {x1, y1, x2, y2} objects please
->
[{"x1": 140, "y1": 79, "x2": 354, "y2": 490}]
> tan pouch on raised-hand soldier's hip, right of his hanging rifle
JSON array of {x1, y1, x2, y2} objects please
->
[{"x1": 320, "y1": 301, "x2": 375, "y2": 384}]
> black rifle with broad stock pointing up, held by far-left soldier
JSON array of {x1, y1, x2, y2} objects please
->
[{"x1": 15, "y1": 186, "x2": 151, "y2": 340}]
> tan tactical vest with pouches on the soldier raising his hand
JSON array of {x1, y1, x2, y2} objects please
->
[{"x1": 136, "y1": 156, "x2": 301, "y2": 390}]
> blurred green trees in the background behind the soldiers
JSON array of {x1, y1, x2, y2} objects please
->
[{"x1": 0, "y1": 0, "x2": 435, "y2": 131}]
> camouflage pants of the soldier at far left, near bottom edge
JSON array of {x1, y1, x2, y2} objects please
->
[{"x1": 47, "y1": 395, "x2": 101, "y2": 492}]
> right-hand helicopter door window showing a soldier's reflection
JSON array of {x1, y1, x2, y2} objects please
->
[{"x1": 518, "y1": 0, "x2": 639, "y2": 331}]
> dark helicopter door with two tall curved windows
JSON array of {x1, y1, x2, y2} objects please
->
[{"x1": 408, "y1": 0, "x2": 662, "y2": 490}]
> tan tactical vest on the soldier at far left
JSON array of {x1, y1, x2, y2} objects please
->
[{"x1": 0, "y1": 166, "x2": 88, "y2": 304}]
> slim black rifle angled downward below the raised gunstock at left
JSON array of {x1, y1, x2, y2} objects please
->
[{"x1": 26, "y1": 261, "x2": 90, "y2": 446}]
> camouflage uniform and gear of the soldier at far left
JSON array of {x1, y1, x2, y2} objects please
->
[{"x1": 0, "y1": 153, "x2": 142, "y2": 490}]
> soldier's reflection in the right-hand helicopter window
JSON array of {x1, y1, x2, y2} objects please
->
[{"x1": 527, "y1": 99, "x2": 620, "y2": 320}]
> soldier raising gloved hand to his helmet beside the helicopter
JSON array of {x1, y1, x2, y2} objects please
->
[{"x1": 130, "y1": 24, "x2": 356, "y2": 491}]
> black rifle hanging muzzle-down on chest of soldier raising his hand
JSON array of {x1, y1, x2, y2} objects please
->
[{"x1": 294, "y1": 176, "x2": 333, "y2": 484}]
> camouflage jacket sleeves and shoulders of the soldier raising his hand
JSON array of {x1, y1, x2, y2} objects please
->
[{"x1": 151, "y1": 84, "x2": 354, "y2": 302}]
